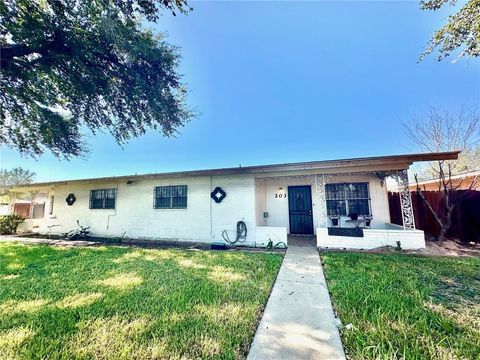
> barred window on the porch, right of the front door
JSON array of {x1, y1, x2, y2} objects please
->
[{"x1": 325, "y1": 183, "x2": 370, "y2": 216}]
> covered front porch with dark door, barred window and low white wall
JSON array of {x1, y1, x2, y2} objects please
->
[{"x1": 255, "y1": 169, "x2": 425, "y2": 249}]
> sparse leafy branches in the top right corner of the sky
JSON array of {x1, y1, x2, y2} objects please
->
[{"x1": 420, "y1": 0, "x2": 480, "y2": 60}]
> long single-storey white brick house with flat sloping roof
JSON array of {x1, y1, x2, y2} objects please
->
[{"x1": 6, "y1": 152, "x2": 458, "y2": 249}]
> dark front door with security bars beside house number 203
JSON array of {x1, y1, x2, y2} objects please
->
[{"x1": 288, "y1": 186, "x2": 313, "y2": 235}]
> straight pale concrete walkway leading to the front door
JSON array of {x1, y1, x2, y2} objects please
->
[{"x1": 247, "y1": 240, "x2": 345, "y2": 360}]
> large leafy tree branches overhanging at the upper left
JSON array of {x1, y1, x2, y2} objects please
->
[{"x1": 0, "y1": 0, "x2": 192, "y2": 158}]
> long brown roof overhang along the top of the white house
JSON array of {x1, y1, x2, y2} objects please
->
[{"x1": 8, "y1": 151, "x2": 460, "y2": 189}]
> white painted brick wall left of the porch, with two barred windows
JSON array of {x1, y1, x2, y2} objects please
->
[{"x1": 18, "y1": 176, "x2": 256, "y2": 245}]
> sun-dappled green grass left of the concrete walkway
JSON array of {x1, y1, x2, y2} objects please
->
[{"x1": 0, "y1": 243, "x2": 282, "y2": 359}]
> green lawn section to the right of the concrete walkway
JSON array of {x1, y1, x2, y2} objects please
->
[{"x1": 322, "y1": 253, "x2": 480, "y2": 359}]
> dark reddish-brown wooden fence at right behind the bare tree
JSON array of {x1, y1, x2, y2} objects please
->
[{"x1": 388, "y1": 190, "x2": 480, "y2": 242}]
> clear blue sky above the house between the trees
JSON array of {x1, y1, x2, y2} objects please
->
[{"x1": 0, "y1": 1, "x2": 480, "y2": 181}]
